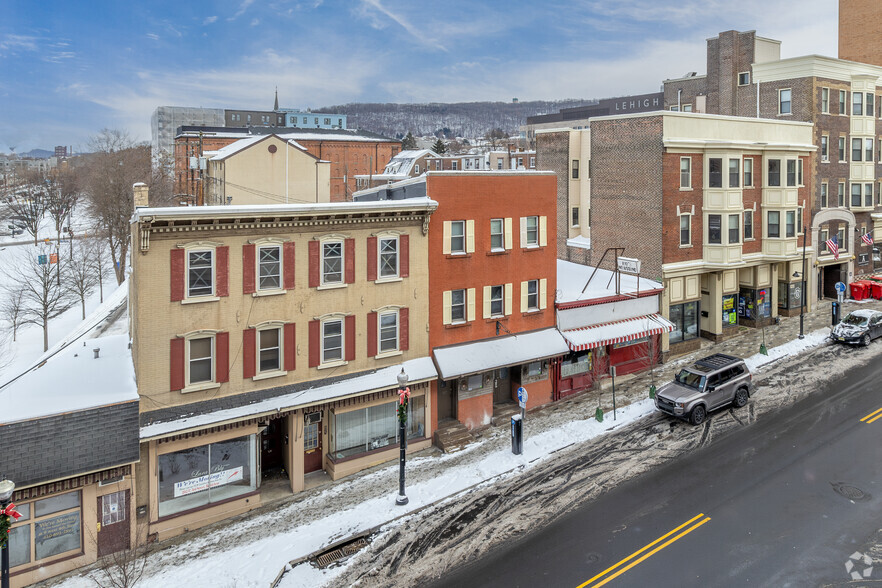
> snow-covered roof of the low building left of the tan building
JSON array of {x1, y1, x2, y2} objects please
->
[{"x1": 0, "y1": 282, "x2": 138, "y2": 424}]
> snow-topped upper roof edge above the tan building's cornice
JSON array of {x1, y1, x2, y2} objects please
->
[{"x1": 131, "y1": 198, "x2": 438, "y2": 222}]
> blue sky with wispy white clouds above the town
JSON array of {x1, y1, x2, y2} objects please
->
[{"x1": 0, "y1": 0, "x2": 838, "y2": 153}]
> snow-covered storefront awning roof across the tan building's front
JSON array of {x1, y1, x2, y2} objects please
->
[{"x1": 141, "y1": 357, "x2": 438, "y2": 440}]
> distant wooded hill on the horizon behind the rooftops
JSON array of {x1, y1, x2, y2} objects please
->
[{"x1": 314, "y1": 99, "x2": 593, "y2": 138}]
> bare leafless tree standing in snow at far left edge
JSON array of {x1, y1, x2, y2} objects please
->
[{"x1": 4, "y1": 246, "x2": 75, "y2": 351}]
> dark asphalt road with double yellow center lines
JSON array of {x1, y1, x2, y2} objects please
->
[{"x1": 435, "y1": 354, "x2": 882, "y2": 588}]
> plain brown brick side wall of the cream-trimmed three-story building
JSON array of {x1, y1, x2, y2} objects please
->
[{"x1": 591, "y1": 116, "x2": 663, "y2": 280}]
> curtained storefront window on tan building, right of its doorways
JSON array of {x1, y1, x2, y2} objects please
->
[{"x1": 332, "y1": 396, "x2": 426, "y2": 459}]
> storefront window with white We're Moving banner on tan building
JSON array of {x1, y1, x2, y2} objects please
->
[{"x1": 159, "y1": 435, "x2": 257, "y2": 517}]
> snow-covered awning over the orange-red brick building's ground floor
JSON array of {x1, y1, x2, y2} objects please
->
[{"x1": 434, "y1": 328, "x2": 569, "y2": 380}]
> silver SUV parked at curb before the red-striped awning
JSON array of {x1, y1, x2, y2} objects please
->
[{"x1": 655, "y1": 353, "x2": 754, "y2": 425}]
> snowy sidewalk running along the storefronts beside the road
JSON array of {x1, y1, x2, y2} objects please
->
[{"x1": 48, "y1": 301, "x2": 882, "y2": 588}]
